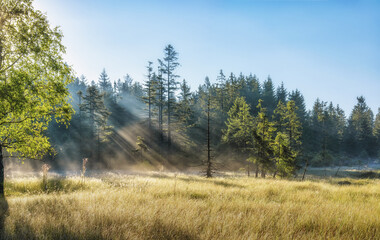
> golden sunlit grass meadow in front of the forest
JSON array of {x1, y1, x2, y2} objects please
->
[{"x1": 3, "y1": 174, "x2": 380, "y2": 239}]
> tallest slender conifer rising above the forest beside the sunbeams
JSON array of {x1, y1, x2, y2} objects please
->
[{"x1": 158, "y1": 44, "x2": 179, "y2": 146}]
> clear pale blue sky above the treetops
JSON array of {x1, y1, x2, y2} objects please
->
[{"x1": 34, "y1": 0, "x2": 380, "y2": 116}]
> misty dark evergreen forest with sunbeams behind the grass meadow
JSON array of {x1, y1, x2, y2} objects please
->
[{"x1": 47, "y1": 45, "x2": 380, "y2": 176}]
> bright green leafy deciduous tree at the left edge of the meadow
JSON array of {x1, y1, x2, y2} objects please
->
[{"x1": 0, "y1": 0, "x2": 73, "y2": 196}]
